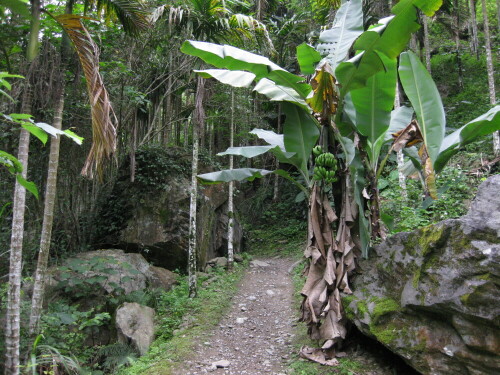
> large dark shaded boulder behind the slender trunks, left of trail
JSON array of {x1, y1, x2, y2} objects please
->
[{"x1": 94, "y1": 150, "x2": 243, "y2": 270}]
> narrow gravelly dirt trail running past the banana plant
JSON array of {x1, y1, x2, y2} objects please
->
[{"x1": 174, "y1": 258, "x2": 296, "y2": 375}]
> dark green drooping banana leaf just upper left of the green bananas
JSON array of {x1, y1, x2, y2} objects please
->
[{"x1": 282, "y1": 102, "x2": 319, "y2": 181}]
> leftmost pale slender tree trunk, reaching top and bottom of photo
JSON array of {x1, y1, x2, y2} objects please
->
[{"x1": 5, "y1": 0, "x2": 41, "y2": 375}]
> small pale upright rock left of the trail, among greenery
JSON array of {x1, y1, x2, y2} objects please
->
[{"x1": 116, "y1": 302, "x2": 155, "y2": 355}]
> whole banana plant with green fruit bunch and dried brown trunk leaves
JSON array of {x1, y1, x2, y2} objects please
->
[{"x1": 182, "y1": 0, "x2": 500, "y2": 360}]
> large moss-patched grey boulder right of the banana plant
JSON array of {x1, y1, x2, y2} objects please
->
[{"x1": 342, "y1": 175, "x2": 500, "y2": 375}]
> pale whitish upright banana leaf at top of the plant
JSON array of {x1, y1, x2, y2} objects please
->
[{"x1": 318, "y1": 0, "x2": 363, "y2": 70}]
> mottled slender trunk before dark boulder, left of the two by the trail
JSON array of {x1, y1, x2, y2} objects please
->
[{"x1": 188, "y1": 77, "x2": 205, "y2": 298}]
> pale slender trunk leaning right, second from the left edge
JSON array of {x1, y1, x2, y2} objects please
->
[{"x1": 29, "y1": 88, "x2": 64, "y2": 336}]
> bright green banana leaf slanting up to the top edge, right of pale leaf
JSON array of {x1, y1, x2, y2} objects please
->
[{"x1": 335, "y1": 0, "x2": 442, "y2": 95}]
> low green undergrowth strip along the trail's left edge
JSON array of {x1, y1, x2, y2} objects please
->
[{"x1": 118, "y1": 262, "x2": 247, "y2": 375}]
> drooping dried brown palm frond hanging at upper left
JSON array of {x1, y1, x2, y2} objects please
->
[{"x1": 54, "y1": 14, "x2": 118, "y2": 178}]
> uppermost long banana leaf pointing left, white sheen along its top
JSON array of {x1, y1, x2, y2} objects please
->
[{"x1": 181, "y1": 40, "x2": 311, "y2": 99}]
